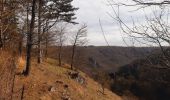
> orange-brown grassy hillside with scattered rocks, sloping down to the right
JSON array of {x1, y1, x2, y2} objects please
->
[{"x1": 14, "y1": 59, "x2": 121, "y2": 100}]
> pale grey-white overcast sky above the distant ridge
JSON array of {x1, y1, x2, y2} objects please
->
[{"x1": 73, "y1": 0, "x2": 165, "y2": 46}]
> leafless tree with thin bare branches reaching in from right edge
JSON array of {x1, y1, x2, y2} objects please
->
[{"x1": 109, "y1": 0, "x2": 170, "y2": 69}]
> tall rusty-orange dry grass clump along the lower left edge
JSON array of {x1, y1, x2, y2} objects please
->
[{"x1": 0, "y1": 50, "x2": 15, "y2": 100}]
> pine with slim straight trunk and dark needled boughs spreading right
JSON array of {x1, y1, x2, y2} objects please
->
[{"x1": 38, "y1": 0, "x2": 78, "y2": 63}]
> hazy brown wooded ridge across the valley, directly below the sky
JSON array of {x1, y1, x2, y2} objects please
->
[{"x1": 49, "y1": 46, "x2": 158, "y2": 75}]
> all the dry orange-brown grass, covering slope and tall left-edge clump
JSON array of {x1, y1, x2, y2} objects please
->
[{"x1": 0, "y1": 52, "x2": 121, "y2": 100}]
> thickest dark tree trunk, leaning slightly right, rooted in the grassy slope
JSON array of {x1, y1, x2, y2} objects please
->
[{"x1": 23, "y1": 0, "x2": 36, "y2": 76}]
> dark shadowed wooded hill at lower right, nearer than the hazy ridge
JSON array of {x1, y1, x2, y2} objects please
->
[{"x1": 112, "y1": 48, "x2": 170, "y2": 100}]
